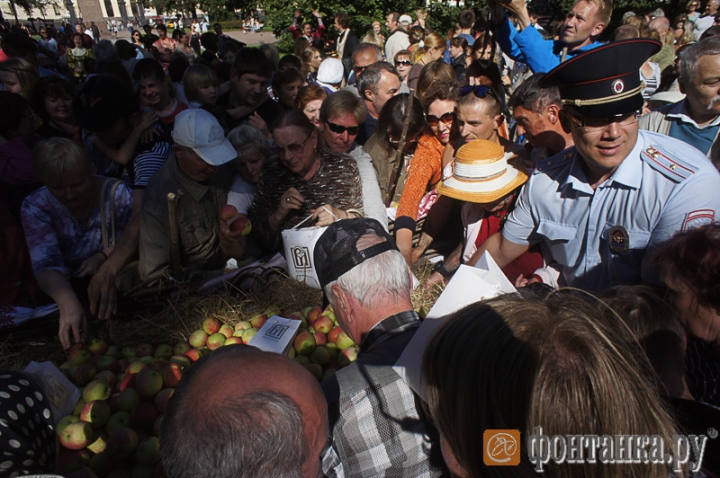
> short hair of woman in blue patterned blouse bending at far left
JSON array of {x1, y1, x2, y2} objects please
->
[{"x1": 32, "y1": 138, "x2": 92, "y2": 187}]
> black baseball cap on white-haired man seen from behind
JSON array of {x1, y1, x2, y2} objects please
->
[{"x1": 313, "y1": 218, "x2": 398, "y2": 289}]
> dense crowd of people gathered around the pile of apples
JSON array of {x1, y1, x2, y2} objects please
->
[{"x1": 0, "y1": 0, "x2": 720, "y2": 478}]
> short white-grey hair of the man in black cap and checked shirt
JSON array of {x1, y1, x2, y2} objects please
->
[{"x1": 325, "y1": 234, "x2": 412, "y2": 308}]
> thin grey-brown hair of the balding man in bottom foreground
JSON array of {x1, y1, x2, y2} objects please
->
[{"x1": 160, "y1": 390, "x2": 309, "y2": 478}]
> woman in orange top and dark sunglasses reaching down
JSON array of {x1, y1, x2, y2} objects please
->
[{"x1": 395, "y1": 82, "x2": 458, "y2": 264}]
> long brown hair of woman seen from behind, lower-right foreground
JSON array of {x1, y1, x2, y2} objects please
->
[{"x1": 422, "y1": 291, "x2": 676, "y2": 478}]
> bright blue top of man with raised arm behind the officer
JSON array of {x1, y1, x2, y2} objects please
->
[{"x1": 497, "y1": 15, "x2": 602, "y2": 73}]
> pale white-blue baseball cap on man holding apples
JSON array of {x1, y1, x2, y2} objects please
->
[{"x1": 172, "y1": 108, "x2": 237, "y2": 166}]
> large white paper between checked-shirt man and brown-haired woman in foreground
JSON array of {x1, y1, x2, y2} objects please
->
[{"x1": 393, "y1": 252, "x2": 517, "y2": 401}]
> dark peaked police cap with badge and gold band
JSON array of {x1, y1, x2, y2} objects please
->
[{"x1": 540, "y1": 38, "x2": 662, "y2": 118}]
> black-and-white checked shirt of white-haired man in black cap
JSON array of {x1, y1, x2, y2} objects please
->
[{"x1": 322, "y1": 311, "x2": 444, "y2": 477}]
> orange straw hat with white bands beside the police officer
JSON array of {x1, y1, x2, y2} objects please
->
[{"x1": 438, "y1": 139, "x2": 528, "y2": 203}]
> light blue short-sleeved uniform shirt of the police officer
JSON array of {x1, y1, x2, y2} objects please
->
[{"x1": 503, "y1": 131, "x2": 720, "y2": 292}]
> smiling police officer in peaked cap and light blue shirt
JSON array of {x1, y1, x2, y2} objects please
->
[{"x1": 470, "y1": 39, "x2": 720, "y2": 292}]
